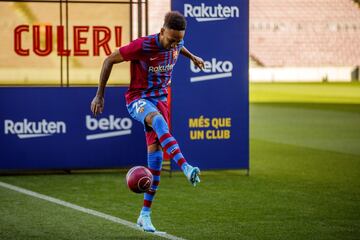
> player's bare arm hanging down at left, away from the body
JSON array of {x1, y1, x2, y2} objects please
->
[{"x1": 91, "y1": 49, "x2": 124, "y2": 116}]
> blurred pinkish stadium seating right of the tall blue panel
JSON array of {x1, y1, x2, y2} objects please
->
[{"x1": 250, "y1": 0, "x2": 360, "y2": 67}]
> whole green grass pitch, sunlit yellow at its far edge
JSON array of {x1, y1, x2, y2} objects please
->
[{"x1": 0, "y1": 84, "x2": 360, "y2": 240}]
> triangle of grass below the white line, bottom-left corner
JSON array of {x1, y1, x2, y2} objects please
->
[{"x1": 0, "y1": 188, "x2": 156, "y2": 239}]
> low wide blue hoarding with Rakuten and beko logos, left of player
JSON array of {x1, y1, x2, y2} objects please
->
[{"x1": 0, "y1": 87, "x2": 147, "y2": 170}]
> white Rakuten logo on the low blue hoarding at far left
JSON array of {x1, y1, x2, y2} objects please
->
[{"x1": 4, "y1": 118, "x2": 66, "y2": 139}]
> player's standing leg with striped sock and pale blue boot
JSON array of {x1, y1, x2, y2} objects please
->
[{"x1": 137, "y1": 142, "x2": 163, "y2": 232}]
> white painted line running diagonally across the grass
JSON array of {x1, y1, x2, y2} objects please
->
[{"x1": 0, "y1": 181, "x2": 185, "y2": 240}]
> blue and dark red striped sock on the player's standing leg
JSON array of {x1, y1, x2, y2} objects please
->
[{"x1": 141, "y1": 150, "x2": 163, "y2": 213}]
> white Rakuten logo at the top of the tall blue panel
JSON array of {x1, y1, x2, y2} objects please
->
[{"x1": 184, "y1": 3, "x2": 239, "y2": 22}]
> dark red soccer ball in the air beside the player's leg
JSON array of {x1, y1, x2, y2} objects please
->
[{"x1": 126, "y1": 166, "x2": 153, "y2": 193}]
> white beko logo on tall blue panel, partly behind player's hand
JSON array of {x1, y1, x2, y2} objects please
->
[{"x1": 190, "y1": 58, "x2": 233, "y2": 82}]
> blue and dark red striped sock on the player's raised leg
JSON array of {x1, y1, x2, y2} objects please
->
[{"x1": 152, "y1": 114, "x2": 187, "y2": 170}]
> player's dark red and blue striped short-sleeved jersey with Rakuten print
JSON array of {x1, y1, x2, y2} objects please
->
[{"x1": 119, "y1": 34, "x2": 184, "y2": 105}]
